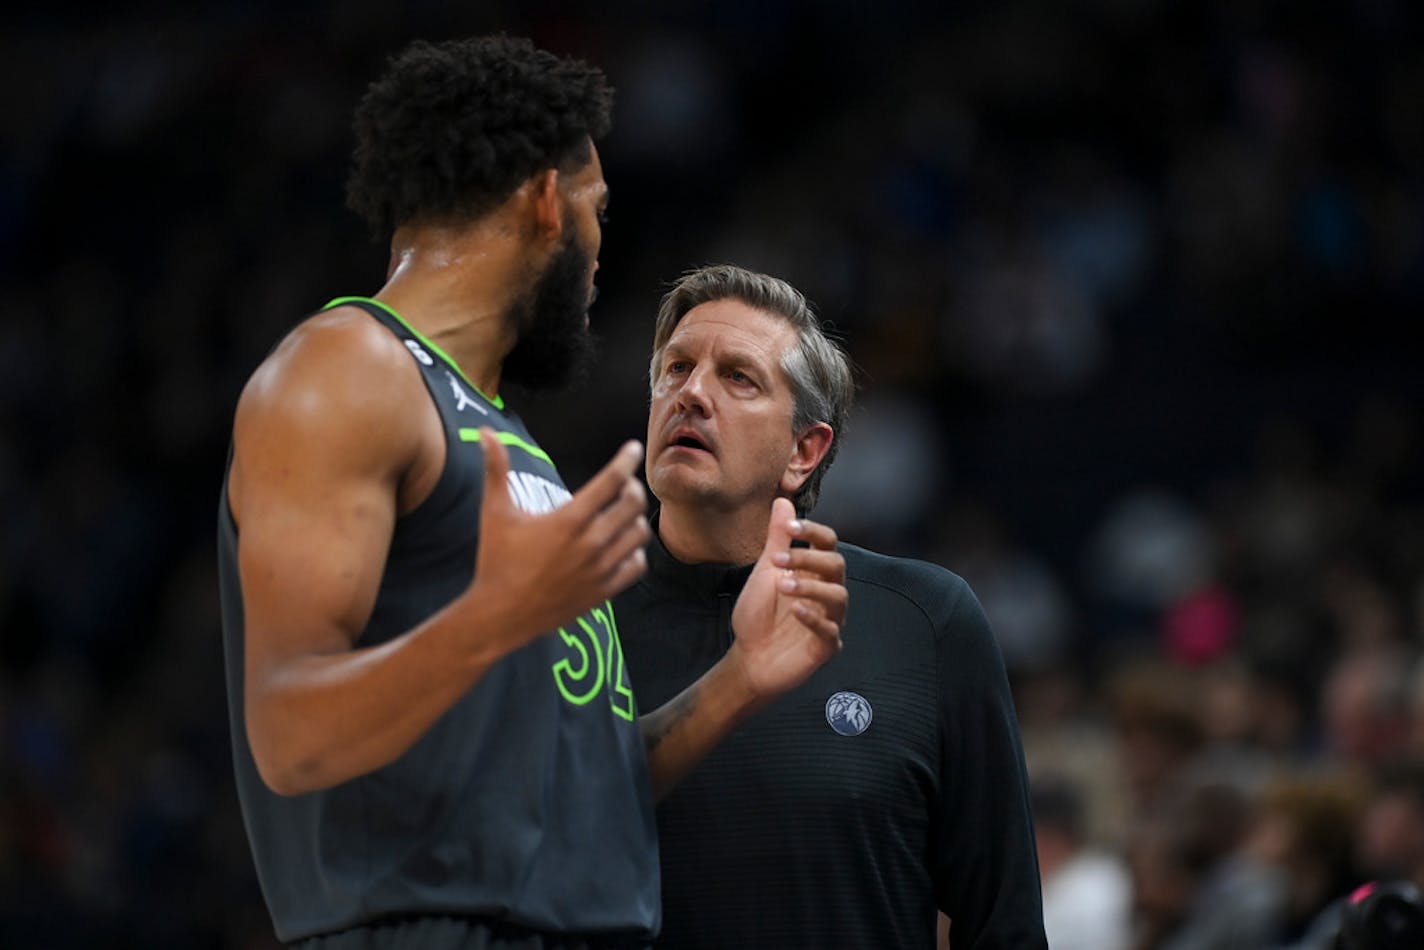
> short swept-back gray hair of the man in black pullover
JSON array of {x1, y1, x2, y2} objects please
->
[{"x1": 648, "y1": 263, "x2": 856, "y2": 517}]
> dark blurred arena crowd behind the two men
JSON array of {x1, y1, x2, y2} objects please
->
[{"x1": 0, "y1": 0, "x2": 1424, "y2": 950}]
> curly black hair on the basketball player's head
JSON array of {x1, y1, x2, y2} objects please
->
[{"x1": 346, "y1": 36, "x2": 612, "y2": 238}]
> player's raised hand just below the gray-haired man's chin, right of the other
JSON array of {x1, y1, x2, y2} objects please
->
[{"x1": 728, "y1": 499, "x2": 850, "y2": 701}]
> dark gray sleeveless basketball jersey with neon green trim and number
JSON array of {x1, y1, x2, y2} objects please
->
[{"x1": 219, "y1": 298, "x2": 659, "y2": 940}]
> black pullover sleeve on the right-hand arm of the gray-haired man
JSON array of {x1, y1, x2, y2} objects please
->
[{"x1": 931, "y1": 575, "x2": 1048, "y2": 950}]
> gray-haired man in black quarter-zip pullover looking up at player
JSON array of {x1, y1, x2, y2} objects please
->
[{"x1": 614, "y1": 266, "x2": 1045, "y2": 950}]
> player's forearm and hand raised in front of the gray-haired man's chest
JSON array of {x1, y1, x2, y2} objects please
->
[{"x1": 639, "y1": 499, "x2": 849, "y2": 798}]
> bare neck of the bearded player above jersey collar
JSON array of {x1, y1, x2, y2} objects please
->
[{"x1": 376, "y1": 225, "x2": 532, "y2": 396}]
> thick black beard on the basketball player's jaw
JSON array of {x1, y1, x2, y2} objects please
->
[{"x1": 501, "y1": 231, "x2": 595, "y2": 389}]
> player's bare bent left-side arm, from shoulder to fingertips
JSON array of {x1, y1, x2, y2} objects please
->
[{"x1": 229, "y1": 310, "x2": 648, "y2": 795}]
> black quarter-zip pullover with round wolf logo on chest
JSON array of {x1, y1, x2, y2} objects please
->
[{"x1": 614, "y1": 524, "x2": 1047, "y2": 950}]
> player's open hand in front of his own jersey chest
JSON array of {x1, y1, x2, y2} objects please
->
[{"x1": 471, "y1": 429, "x2": 651, "y2": 649}]
